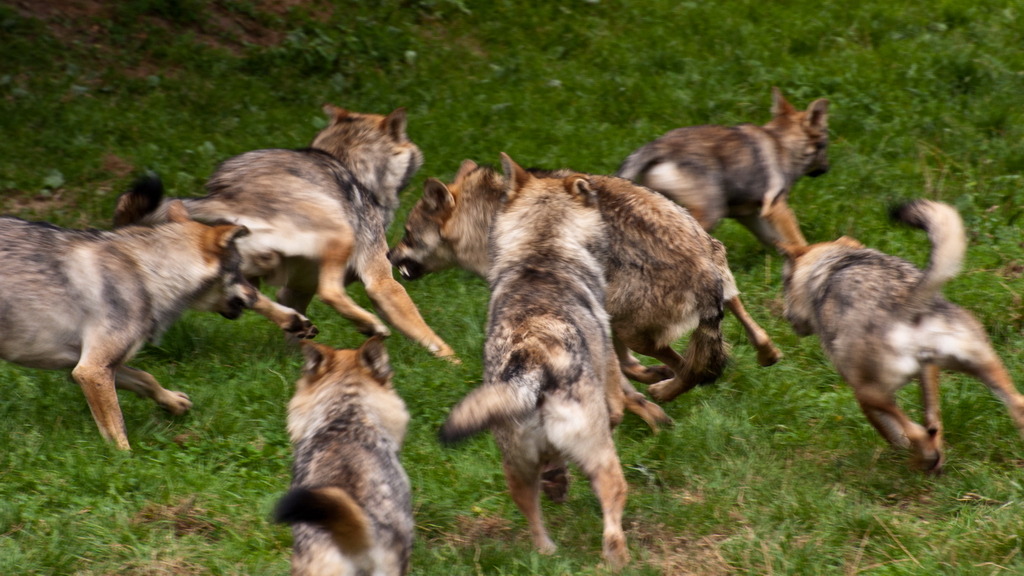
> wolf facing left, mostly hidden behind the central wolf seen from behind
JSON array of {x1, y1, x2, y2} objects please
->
[{"x1": 388, "y1": 155, "x2": 781, "y2": 403}]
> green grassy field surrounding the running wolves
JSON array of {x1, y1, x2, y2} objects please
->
[{"x1": 0, "y1": 0, "x2": 1024, "y2": 575}]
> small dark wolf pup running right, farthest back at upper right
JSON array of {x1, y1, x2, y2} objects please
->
[{"x1": 617, "y1": 87, "x2": 828, "y2": 249}]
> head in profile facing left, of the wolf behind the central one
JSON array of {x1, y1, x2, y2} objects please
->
[{"x1": 388, "y1": 160, "x2": 505, "y2": 280}]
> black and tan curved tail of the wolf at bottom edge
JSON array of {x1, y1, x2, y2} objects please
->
[{"x1": 273, "y1": 486, "x2": 372, "y2": 554}]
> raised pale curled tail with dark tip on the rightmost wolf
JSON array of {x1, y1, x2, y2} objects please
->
[{"x1": 891, "y1": 200, "x2": 967, "y2": 310}]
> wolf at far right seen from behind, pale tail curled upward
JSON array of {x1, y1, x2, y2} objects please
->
[{"x1": 779, "y1": 200, "x2": 1024, "y2": 474}]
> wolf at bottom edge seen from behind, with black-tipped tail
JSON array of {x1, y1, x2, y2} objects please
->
[{"x1": 274, "y1": 336, "x2": 414, "y2": 576}]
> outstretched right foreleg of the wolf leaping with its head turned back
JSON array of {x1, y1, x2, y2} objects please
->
[{"x1": 360, "y1": 247, "x2": 458, "y2": 362}]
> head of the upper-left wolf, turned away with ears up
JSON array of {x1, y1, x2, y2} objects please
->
[{"x1": 311, "y1": 104, "x2": 423, "y2": 198}]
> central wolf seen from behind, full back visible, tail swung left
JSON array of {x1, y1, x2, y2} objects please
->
[{"x1": 439, "y1": 154, "x2": 628, "y2": 567}]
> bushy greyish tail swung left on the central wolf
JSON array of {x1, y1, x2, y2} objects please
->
[{"x1": 437, "y1": 383, "x2": 537, "y2": 444}]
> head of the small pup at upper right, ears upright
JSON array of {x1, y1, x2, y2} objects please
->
[{"x1": 765, "y1": 86, "x2": 828, "y2": 177}]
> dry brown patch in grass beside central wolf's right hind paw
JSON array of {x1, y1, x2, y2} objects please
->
[{"x1": 626, "y1": 522, "x2": 734, "y2": 576}]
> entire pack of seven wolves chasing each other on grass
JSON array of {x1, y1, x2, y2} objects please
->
[{"x1": 6, "y1": 88, "x2": 1024, "y2": 575}]
